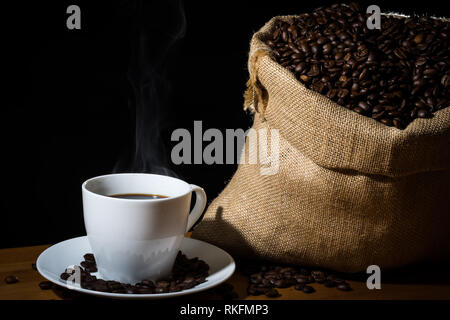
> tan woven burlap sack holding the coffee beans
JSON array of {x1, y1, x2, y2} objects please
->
[{"x1": 192, "y1": 16, "x2": 450, "y2": 272}]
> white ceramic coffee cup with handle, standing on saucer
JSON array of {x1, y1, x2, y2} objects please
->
[{"x1": 82, "y1": 173, "x2": 206, "y2": 284}]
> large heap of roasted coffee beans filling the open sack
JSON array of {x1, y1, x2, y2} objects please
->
[{"x1": 266, "y1": 3, "x2": 450, "y2": 129}]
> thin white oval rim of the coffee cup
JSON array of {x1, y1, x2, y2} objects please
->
[{"x1": 81, "y1": 173, "x2": 192, "y2": 203}]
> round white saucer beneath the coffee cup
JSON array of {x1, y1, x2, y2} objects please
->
[{"x1": 36, "y1": 236, "x2": 235, "y2": 299}]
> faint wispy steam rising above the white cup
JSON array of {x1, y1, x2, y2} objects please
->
[{"x1": 113, "y1": 0, "x2": 186, "y2": 176}]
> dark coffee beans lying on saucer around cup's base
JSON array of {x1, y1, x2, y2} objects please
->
[{"x1": 60, "y1": 252, "x2": 209, "y2": 294}]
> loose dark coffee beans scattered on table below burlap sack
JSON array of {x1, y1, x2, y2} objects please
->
[{"x1": 243, "y1": 264, "x2": 352, "y2": 298}]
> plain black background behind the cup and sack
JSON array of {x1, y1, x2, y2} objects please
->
[{"x1": 0, "y1": 0, "x2": 448, "y2": 247}]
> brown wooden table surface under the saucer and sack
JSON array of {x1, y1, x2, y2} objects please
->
[{"x1": 0, "y1": 245, "x2": 450, "y2": 300}]
